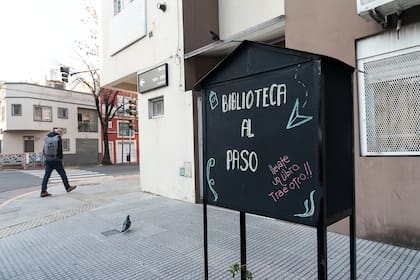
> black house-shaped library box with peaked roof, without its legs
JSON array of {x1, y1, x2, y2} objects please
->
[{"x1": 195, "y1": 41, "x2": 354, "y2": 226}]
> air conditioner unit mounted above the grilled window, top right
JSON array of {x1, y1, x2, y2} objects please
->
[{"x1": 357, "y1": 0, "x2": 420, "y2": 20}]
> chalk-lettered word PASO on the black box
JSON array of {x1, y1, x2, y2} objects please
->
[{"x1": 226, "y1": 149, "x2": 258, "y2": 172}]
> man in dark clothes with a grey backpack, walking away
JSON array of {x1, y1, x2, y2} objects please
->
[{"x1": 41, "y1": 128, "x2": 77, "y2": 197}]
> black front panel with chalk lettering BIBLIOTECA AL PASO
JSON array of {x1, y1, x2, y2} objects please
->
[{"x1": 205, "y1": 60, "x2": 321, "y2": 225}]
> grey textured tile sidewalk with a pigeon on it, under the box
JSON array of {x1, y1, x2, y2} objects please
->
[{"x1": 0, "y1": 176, "x2": 420, "y2": 280}]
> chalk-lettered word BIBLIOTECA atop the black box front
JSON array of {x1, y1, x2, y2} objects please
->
[{"x1": 221, "y1": 84, "x2": 287, "y2": 113}]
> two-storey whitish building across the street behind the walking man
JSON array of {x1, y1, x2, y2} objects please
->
[{"x1": 0, "y1": 83, "x2": 101, "y2": 165}]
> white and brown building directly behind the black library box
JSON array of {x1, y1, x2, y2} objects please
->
[{"x1": 101, "y1": 0, "x2": 420, "y2": 247}]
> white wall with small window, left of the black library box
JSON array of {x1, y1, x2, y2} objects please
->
[{"x1": 101, "y1": 0, "x2": 195, "y2": 202}]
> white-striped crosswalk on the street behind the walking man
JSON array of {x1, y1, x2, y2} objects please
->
[{"x1": 21, "y1": 169, "x2": 112, "y2": 184}]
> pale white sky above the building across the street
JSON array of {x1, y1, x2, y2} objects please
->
[{"x1": 0, "y1": 0, "x2": 97, "y2": 82}]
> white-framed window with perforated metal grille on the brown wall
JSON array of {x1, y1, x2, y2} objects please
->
[{"x1": 359, "y1": 51, "x2": 420, "y2": 155}]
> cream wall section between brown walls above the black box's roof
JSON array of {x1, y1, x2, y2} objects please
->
[{"x1": 219, "y1": 0, "x2": 284, "y2": 39}]
